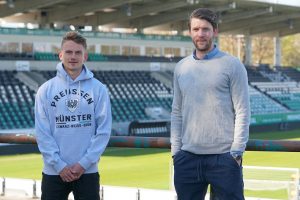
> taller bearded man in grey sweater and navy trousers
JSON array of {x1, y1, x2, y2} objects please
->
[{"x1": 171, "y1": 8, "x2": 250, "y2": 200}]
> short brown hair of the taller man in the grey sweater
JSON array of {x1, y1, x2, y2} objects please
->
[{"x1": 188, "y1": 8, "x2": 218, "y2": 30}]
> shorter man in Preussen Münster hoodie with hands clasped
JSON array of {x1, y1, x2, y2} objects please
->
[{"x1": 35, "y1": 31, "x2": 112, "y2": 200}]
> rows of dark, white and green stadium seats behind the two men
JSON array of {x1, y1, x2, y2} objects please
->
[{"x1": 0, "y1": 64, "x2": 300, "y2": 135}]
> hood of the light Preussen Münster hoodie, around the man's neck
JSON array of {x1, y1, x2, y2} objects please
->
[{"x1": 56, "y1": 62, "x2": 94, "y2": 83}]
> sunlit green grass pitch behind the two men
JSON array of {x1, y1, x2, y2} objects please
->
[{"x1": 0, "y1": 130, "x2": 300, "y2": 199}]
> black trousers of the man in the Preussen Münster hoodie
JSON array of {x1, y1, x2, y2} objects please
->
[{"x1": 42, "y1": 173, "x2": 100, "y2": 200}]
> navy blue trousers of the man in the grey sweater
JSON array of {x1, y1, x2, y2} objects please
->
[{"x1": 174, "y1": 150, "x2": 244, "y2": 200}]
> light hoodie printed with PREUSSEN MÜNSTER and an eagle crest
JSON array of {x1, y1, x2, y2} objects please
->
[{"x1": 35, "y1": 63, "x2": 112, "y2": 175}]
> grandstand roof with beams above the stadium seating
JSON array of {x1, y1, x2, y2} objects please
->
[{"x1": 0, "y1": 0, "x2": 300, "y2": 36}]
